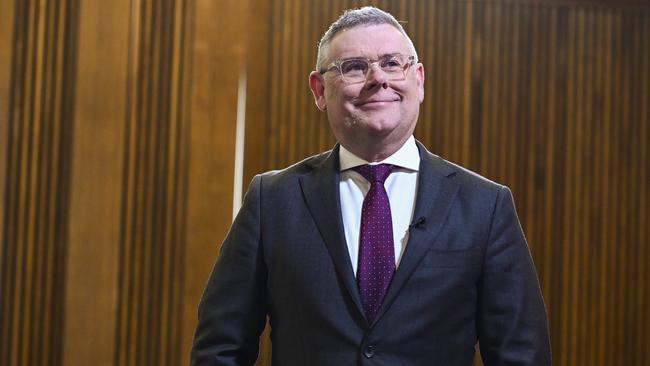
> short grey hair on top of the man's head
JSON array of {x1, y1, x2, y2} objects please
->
[{"x1": 316, "y1": 6, "x2": 418, "y2": 71}]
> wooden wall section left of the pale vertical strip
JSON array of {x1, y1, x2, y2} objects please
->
[{"x1": 0, "y1": 0, "x2": 247, "y2": 366}]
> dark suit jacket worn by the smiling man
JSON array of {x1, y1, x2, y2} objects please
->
[{"x1": 191, "y1": 143, "x2": 551, "y2": 366}]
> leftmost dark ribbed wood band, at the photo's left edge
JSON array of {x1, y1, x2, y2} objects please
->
[{"x1": 0, "y1": 0, "x2": 78, "y2": 365}]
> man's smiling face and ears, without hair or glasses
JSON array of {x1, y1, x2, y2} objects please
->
[{"x1": 310, "y1": 24, "x2": 424, "y2": 152}]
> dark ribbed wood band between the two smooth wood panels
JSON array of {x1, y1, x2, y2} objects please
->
[{"x1": 114, "y1": 0, "x2": 189, "y2": 365}]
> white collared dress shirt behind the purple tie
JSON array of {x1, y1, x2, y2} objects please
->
[{"x1": 339, "y1": 136, "x2": 420, "y2": 275}]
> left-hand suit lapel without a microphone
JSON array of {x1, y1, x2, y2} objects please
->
[{"x1": 300, "y1": 145, "x2": 363, "y2": 314}]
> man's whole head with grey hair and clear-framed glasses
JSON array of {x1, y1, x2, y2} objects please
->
[{"x1": 309, "y1": 7, "x2": 424, "y2": 160}]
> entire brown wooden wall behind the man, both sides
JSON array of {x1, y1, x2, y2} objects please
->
[{"x1": 0, "y1": 0, "x2": 650, "y2": 366}]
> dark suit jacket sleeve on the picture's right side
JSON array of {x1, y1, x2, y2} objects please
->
[{"x1": 477, "y1": 187, "x2": 551, "y2": 366}]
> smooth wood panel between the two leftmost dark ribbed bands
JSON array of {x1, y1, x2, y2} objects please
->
[{"x1": 61, "y1": 1, "x2": 130, "y2": 365}]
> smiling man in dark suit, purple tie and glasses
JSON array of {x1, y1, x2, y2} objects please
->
[{"x1": 191, "y1": 7, "x2": 550, "y2": 366}]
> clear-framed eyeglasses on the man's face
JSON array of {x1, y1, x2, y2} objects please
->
[{"x1": 320, "y1": 54, "x2": 415, "y2": 84}]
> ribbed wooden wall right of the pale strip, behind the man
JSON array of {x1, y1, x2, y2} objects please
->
[{"x1": 245, "y1": 0, "x2": 650, "y2": 366}]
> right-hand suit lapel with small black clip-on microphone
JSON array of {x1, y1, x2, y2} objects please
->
[{"x1": 373, "y1": 142, "x2": 459, "y2": 324}]
